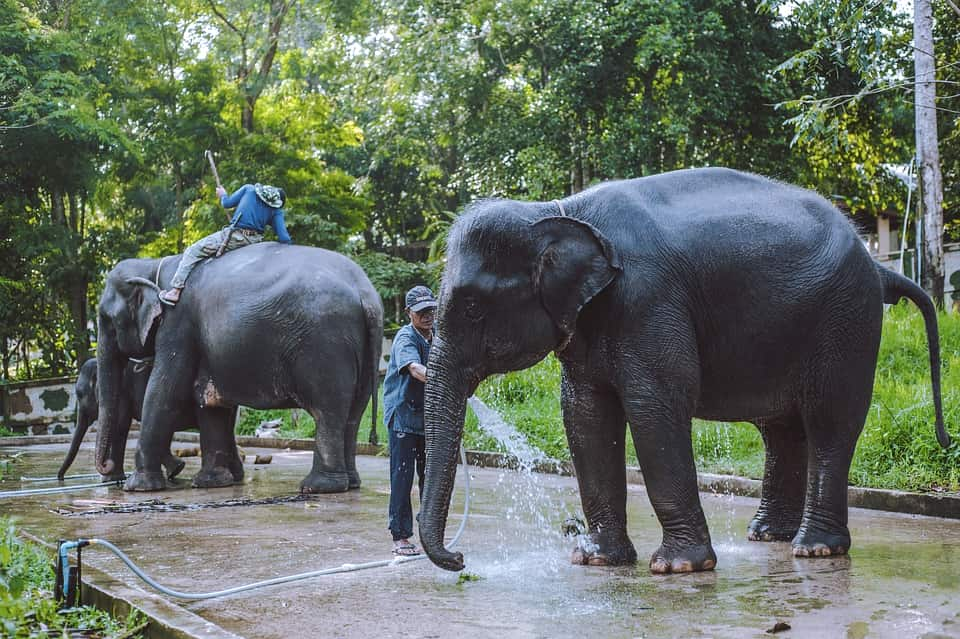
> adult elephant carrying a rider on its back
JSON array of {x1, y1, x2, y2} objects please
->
[{"x1": 96, "y1": 242, "x2": 383, "y2": 493}]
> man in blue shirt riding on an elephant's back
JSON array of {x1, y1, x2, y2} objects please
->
[{"x1": 160, "y1": 184, "x2": 291, "y2": 306}]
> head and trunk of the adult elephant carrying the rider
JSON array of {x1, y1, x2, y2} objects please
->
[{"x1": 96, "y1": 260, "x2": 161, "y2": 475}]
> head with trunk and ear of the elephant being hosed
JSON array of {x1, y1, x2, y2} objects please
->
[{"x1": 420, "y1": 200, "x2": 620, "y2": 570}]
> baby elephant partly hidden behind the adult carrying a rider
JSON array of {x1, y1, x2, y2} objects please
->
[{"x1": 57, "y1": 357, "x2": 185, "y2": 481}]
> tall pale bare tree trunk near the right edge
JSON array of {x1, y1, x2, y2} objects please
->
[{"x1": 913, "y1": 0, "x2": 944, "y2": 308}]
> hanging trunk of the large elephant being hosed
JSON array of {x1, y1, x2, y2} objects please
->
[{"x1": 420, "y1": 337, "x2": 469, "y2": 570}]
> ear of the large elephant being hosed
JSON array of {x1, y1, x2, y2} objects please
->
[{"x1": 533, "y1": 216, "x2": 622, "y2": 350}]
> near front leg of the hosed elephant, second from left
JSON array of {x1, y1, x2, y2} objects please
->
[{"x1": 627, "y1": 390, "x2": 717, "y2": 574}]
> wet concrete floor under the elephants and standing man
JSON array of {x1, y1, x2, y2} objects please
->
[{"x1": 0, "y1": 445, "x2": 960, "y2": 639}]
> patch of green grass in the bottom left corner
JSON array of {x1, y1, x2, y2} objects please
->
[{"x1": 0, "y1": 517, "x2": 145, "y2": 639}]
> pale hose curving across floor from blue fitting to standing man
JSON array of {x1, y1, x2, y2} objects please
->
[{"x1": 68, "y1": 446, "x2": 470, "y2": 601}]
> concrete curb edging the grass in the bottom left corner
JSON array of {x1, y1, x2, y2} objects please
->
[{"x1": 19, "y1": 531, "x2": 243, "y2": 639}]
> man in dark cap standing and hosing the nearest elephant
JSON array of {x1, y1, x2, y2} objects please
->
[{"x1": 383, "y1": 286, "x2": 437, "y2": 556}]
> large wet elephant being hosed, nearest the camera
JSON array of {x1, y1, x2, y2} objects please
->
[{"x1": 420, "y1": 168, "x2": 949, "y2": 573}]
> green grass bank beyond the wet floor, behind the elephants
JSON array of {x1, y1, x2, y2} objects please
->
[{"x1": 232, "y1": 303, "x2": 960, "y2": 491}]
